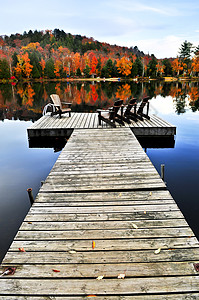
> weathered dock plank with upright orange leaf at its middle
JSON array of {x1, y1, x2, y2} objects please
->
[{"x1": 9, "y1": 236, "x2": 199, "y2": 252}]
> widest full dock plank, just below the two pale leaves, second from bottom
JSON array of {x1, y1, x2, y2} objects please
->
[{"x1": 0, "y1": 276, "x2": 199, "y2": 296}]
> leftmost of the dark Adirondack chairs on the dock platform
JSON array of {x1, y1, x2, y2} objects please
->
[{"x1": 97, "y1": 100, "x2": 124, "y2": 127}]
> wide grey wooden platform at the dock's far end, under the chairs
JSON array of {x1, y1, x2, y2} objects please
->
[{"x1": 28, "y1": 112, "x2": 176, "y2": 138}]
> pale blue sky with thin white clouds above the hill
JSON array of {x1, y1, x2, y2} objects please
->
[{"x1": 0, "y1": 0, "x2": 199, "y2": 58}]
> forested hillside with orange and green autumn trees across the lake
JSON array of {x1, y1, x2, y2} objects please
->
[{"x1": 0, "y1": 29, "x2": 199, "y2": 82}]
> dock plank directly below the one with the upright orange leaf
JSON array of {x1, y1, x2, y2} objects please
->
[{"x1": 3, "y1": 248, "x2": 199, "y2": 264}]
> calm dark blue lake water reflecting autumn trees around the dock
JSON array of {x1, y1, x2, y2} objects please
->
[{"x1": 0, "y1": 82, "x2": 199, "y2": 261}]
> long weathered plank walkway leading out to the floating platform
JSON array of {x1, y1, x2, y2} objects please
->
[{"x1": 0, "y1": 128, "x2": 199, "y2": 300}]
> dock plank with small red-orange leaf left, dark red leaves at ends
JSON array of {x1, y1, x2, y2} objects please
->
[{"x1": 0, "y1": 261, "x2": 197, "y2": 279}]
